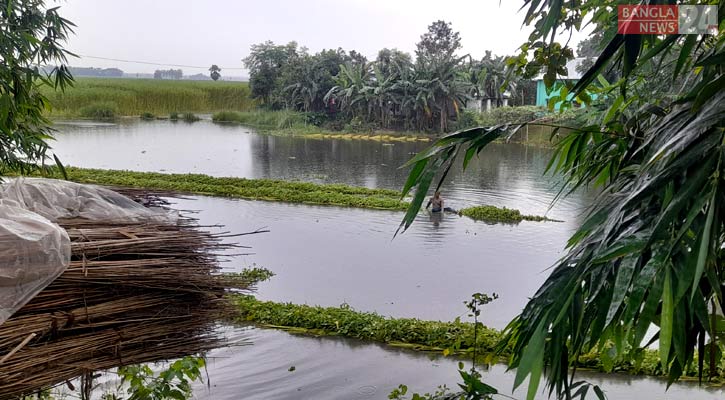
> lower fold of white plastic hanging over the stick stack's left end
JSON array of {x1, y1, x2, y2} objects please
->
[{"x1": 0, "y1": 206, "x2": 71, "y2": 325}]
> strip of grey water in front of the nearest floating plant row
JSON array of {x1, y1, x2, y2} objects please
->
[{"x1": 194, "y1": 329, "x2": 725, "y2": 400}]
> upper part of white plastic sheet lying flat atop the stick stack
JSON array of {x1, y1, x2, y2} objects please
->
[{"x1": 0, "y1": 178, "x2": 174, "y2": 221}]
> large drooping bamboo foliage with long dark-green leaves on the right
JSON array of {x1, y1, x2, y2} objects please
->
[{"x1": 401, "y1": 0, "x2": 725, "y2": 399}]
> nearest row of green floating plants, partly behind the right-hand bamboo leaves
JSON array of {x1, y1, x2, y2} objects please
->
[{"x1": 234, "y1": 295, "x2": 724, "y2": 383}]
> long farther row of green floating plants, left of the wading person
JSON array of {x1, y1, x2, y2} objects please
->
[{"x1": 42, "y1": 167, "x2": 408, "y2": 210}]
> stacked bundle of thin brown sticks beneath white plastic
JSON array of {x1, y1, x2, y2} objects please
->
[{"x1": 0, "y1": 191, "x2": 257, "y2": 399}]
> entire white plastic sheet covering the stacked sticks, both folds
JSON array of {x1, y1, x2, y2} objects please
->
[{"x1": 0, "y1": 178, "x2": 177, "y2": 325}]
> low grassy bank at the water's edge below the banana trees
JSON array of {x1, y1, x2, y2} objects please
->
[{"x1": 212, "y1": 110, "x2": 432, "y2": 142}]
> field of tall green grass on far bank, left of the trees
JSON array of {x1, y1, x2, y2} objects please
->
[{"x1": 41, "y1": 78, "x2": 255, "y2": 118}]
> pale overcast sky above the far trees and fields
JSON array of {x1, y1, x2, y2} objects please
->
[{"x1": 55, "y1": 0, "x2": 588, "y2": 76}]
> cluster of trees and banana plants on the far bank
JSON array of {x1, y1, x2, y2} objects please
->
[{"x1": 243, "y1": 21, "x2": 536, "y2": 132}]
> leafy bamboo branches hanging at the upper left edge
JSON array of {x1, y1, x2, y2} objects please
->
[{"x1": 0, "y1": 0, "x2": 74, "y2": 174}]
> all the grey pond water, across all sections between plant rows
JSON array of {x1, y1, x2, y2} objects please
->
[{"x1": 53, "y1": 121, "x2": 723, "y2": 400}]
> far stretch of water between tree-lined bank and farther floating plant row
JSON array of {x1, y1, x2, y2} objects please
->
[{"x1": 53, "y1": 121, "x2": 589, "y2": 220}]
